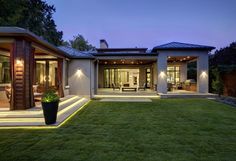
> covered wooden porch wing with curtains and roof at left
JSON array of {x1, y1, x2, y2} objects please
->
[{"x1": 0, "y1": 27, "x2": 65, "y2": 110}]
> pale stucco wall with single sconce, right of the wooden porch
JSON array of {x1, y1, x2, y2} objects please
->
[{"x1": 68, "y1": 59, "x2": 94, "y2": 97}]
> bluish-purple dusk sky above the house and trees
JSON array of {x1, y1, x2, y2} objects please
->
[{"x1": 46, "y1": 0, "x2": 236, "y2": 49}]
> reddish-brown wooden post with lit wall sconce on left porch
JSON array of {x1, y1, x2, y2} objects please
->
[{"x1": 10, "y1": 39, "x2": 34, "y2": 110}]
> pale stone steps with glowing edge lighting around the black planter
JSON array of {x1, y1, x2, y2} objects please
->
[{"x1": 0, "y1": 95, "x2": 89, "y2": 127}]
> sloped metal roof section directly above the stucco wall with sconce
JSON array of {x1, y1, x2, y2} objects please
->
[{"x1": 58, "y1": 46, "x2": 95, "y2": 59}]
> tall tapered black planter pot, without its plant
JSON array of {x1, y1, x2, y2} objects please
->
[{"x1": 42, "y1": 101, "x2": 59, "y2": 125}]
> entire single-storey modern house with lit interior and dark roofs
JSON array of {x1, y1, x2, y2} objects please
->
[{"x1": 0, "y1": 27, "x2": 214, "y2": 110}]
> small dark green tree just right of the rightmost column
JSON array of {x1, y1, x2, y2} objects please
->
[{"x1": 212, "y1": 68, "x2": 224, "y2": 97}]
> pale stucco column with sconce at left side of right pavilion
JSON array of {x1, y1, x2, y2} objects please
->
[{"x1": 157, "y1": 54, "x2": 167, "y2": 94}]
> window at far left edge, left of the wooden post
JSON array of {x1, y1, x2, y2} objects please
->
[{"x1": 0, "y1": 55, "x2": 11, "y2": 84}]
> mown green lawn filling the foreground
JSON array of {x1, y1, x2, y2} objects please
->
[{"x1": 0, "y1": 99, "x2": 236, "y2": 161}]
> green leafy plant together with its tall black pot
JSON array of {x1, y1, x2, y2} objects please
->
[{"x1": 41, "y1": 90, "x2": 60, "y2": 125}]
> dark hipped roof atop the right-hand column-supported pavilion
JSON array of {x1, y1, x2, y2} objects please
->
[{"x1": 152, "y1": 42, "x2": 215, "y2": 52}]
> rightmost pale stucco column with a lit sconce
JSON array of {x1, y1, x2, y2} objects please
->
[{"x1": 197, "y1": 54, "x2": 209, "y2": 93}]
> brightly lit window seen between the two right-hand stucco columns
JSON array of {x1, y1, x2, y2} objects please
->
[{"x1": 167, "y1": 66, "x2": 180, "y2": 84}]
